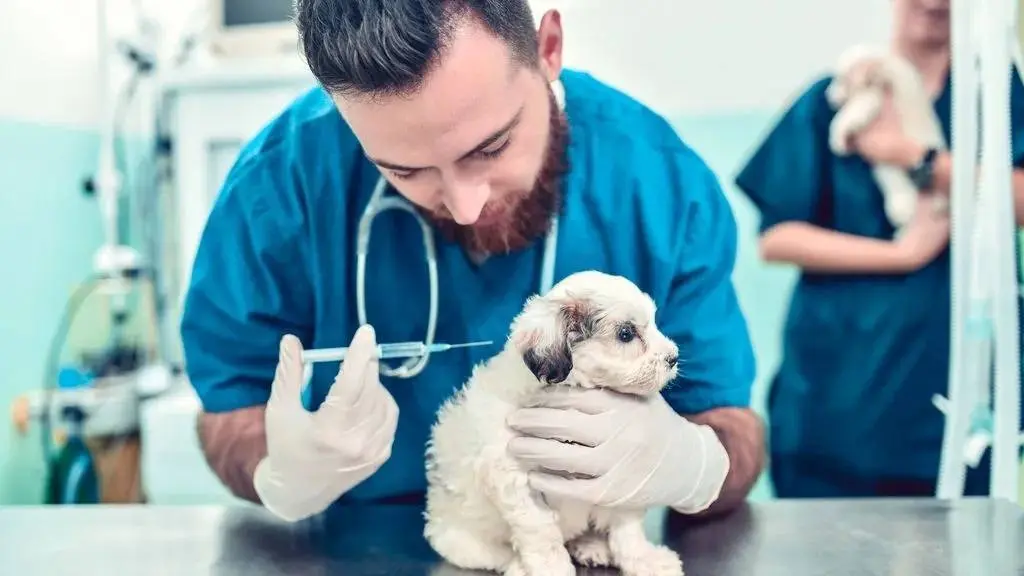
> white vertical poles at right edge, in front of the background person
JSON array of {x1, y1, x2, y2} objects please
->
[{"x1": 933, "y1": 0, "x2": 1021, "y2": 501}]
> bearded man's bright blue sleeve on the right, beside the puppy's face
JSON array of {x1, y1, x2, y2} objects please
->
[{"x1": 658, "y1": 154, "x2": 755, "y2": 414}]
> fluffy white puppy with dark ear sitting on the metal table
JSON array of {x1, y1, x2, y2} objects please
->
[{"x1": 425, "y1": 272, "x2": 683, "y2": 576}]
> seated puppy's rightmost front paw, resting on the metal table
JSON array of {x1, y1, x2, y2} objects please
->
[{"x1": 607, "y1": 510, "x2": 683, "y2": 576}]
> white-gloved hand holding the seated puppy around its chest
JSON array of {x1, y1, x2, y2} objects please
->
[{"x1": 508, "y1": 388, "x2": 729, "y2": 513}]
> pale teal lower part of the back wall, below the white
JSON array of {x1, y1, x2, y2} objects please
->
[{"x1": 0, "y1": 108, "x2": 792, "y2": 504}]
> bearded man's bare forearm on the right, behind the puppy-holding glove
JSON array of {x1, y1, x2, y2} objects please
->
[{"x1": 686, "y1": 408, "x2": 765, "y2": 517}]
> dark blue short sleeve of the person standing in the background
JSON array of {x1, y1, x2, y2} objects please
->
[{"x1": 735, "y1": 79, "x2": 830, "y2": 232}]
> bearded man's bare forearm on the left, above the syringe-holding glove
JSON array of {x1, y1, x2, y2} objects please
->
[{"x1": 198, "y1": 406, "x2": 266, "y2": 503}]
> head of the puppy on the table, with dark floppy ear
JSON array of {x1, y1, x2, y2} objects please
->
[{"x1": 511, "y1": 272, "x2": 679, "y2": 396}]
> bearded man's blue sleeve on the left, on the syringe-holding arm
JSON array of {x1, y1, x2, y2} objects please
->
[{"x1": 181, "y1": 153, "x2": 312, "y2": 412}]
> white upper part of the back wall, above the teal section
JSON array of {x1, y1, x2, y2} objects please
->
[{"x1": 0, "y1": 0, "x2": 890, "y2": 127}]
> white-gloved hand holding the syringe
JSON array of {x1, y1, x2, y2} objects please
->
[{"x1": 253, "y1": 326, "x2": 398, "y2": 522}]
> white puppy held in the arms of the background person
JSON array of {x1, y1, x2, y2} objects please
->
[{"x1": 825, "y1": 46, "x2": 946, "y2": 230}]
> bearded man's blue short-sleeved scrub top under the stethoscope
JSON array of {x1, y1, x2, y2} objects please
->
[{"x1": 181, "y1": 71, "x2": 755, "y2": 500}]
